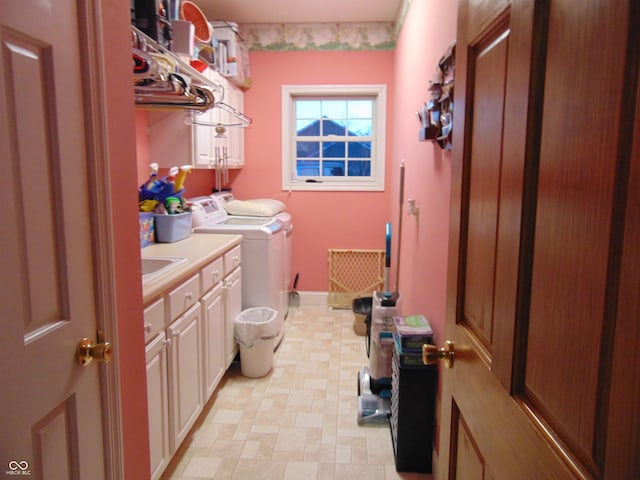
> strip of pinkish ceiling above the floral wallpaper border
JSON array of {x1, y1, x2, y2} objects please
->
[{"x1": 193, "y1": 0, "x2": 403, "y2": 24}]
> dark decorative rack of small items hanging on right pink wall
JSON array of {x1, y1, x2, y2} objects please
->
[{"x1": 418, "y1": 43, "x2": 455, "y2": 150}]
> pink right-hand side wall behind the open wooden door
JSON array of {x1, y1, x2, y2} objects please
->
[{"x1": 390, "y1": 0, "x2": 457, "y2": 343}]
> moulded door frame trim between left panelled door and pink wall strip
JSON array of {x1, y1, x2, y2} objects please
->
[{"x1": 79, "y1": 0, "x2": 124, "y2": 478}]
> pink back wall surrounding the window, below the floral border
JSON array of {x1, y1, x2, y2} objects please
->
[{"x1": 232, "y1": 51, "x2": 394, "y2": 292}]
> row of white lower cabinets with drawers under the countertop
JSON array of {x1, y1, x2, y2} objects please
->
[{"x1": 144, "y1": 245, "x2": 242, "y2": 480}]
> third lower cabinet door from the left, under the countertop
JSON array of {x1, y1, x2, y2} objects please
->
[{"x1": 202, "y1": 284, "x2": 226, "y2": 403}]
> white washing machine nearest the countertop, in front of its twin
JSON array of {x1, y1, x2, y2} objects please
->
[{"x1": 189, "y1": 196, "x2": 288, "y2": 346}]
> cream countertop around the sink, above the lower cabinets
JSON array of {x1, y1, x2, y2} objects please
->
[{"x1": 140, "y1": 233, "x2": 242, "y2": 305}]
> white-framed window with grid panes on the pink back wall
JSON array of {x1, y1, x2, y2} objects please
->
[{"x1": 282, "y1": 85, "x2": 386, "y2": 190}]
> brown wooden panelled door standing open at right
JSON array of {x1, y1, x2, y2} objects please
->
[{"x1": 437, "y1": 0, "x2": 640, "y2": 480}]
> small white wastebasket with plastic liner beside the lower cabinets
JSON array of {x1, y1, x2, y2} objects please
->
[{"x1": 234, "y1": 307, "x2": 282, "y2": 378}]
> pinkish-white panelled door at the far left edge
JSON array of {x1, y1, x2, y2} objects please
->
[{"x1": 0, "y1": 0, "x2": 110, "y2": 480}]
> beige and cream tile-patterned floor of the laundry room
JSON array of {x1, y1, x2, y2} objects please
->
[{"x1": 162, "y1": 306, "x2": 431, "y2": 480}]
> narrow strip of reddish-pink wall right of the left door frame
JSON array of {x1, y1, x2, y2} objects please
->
[{"x1": 106, "y1": 0, "x2": 149, "y2": 480}]
